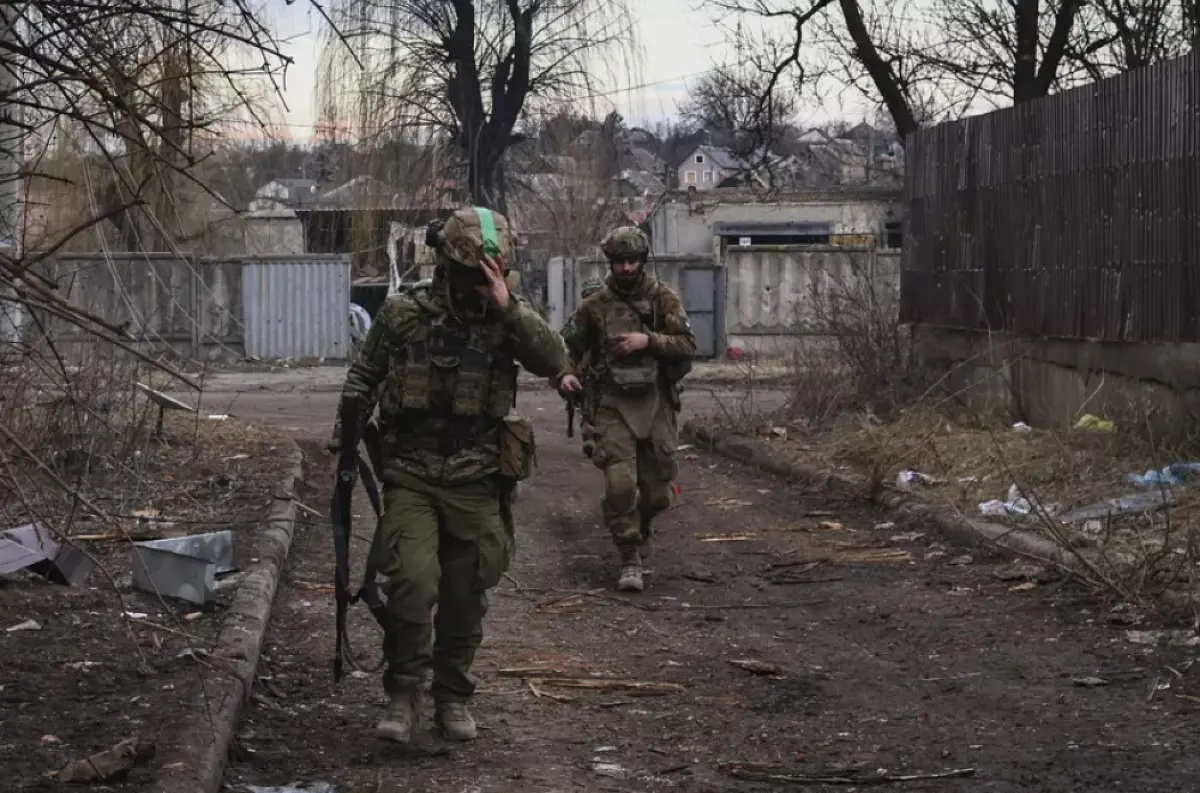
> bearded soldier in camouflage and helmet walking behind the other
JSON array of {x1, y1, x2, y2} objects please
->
[{"x1": 559, "y1": 227, "x2": 696, "y2": 591}]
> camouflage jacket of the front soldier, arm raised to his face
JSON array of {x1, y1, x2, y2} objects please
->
[{"x1": 329, "y1": 282, "x2": 569, "y2": 485}]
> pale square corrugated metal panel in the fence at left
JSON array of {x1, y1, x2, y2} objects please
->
[{"x1": 241, "y1": 254, "x2": 352, "y2": 360}]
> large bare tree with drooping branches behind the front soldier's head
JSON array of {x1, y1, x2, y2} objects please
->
[{"x1": 322, "y1": 0, "x2": 632, "y2": 210}]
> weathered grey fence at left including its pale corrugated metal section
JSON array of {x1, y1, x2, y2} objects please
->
[{"x1": 26, "y1": 253, "x2": 350, "y2": 361}]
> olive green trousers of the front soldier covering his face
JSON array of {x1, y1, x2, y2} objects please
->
[{"x1": 378, "y1": 474, "x2": 512, "y2": 702}]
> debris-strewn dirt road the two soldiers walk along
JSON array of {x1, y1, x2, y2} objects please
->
[{"x1": 211, "y1": 374, "x2": 1200, "y2": 793}]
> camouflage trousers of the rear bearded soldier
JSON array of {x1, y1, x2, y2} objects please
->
[{"x1": 592, "y1": 407, "x2": 678, "y2": 547}]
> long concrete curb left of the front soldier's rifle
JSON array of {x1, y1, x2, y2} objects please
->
[{"x1": 155, "y1": 441, "x2": 304, "y2": 793}]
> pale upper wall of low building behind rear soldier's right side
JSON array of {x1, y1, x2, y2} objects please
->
[{"x1": 650, "y1": 192, "x2": 904, "y2": 256}]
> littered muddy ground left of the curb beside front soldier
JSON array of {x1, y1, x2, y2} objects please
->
[{"x1": 0, "y1": 415, "x2": 296, "y2": 793}]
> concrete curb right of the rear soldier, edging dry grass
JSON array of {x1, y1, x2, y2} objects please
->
[{"x1": 680, "y1": 421, "x2": 1082, "y2": 571}]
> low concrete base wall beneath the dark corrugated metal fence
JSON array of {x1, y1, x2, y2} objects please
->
[{"x1": 914, "y1": 326, "x2": 1200, "y2": 434}]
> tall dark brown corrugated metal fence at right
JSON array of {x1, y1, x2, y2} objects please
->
[{"x1": 901, "y1": 46, "x2": 1200, "y2": 341}]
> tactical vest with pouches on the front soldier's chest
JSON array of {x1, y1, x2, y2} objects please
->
[{"x1": 395, "y1": 313, "x2": 517, "y2": 426}]
